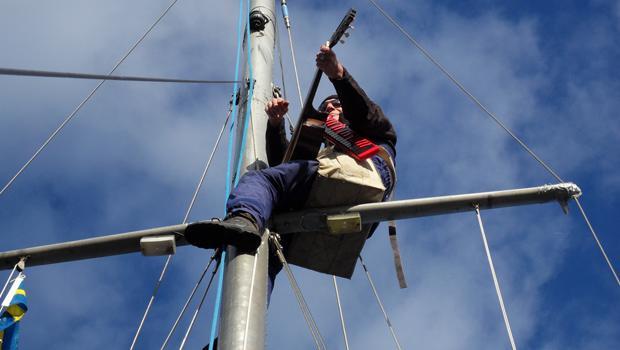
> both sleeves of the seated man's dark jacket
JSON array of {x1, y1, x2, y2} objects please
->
[{"x1": 266, "y1": 69, "x2": 396, "y2": 166}]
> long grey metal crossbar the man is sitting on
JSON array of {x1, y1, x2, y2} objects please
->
[{"x1": 0, "y1": 183, "x2": 581, "y2": 270}]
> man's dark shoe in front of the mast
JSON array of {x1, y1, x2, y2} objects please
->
[{"x1": 185, "y1": 215, "x2": 262, "y2": 252}]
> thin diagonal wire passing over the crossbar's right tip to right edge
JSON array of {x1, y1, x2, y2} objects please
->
[{"x1": 369, "y1": 0, "x2": 620, "y2": 286}]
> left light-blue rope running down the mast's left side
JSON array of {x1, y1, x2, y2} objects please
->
[{"x1": 209, "y1": 0, "x2": 249, "y2": 350}]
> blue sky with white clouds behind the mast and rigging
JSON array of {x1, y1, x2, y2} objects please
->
[{"x1": 0, "y1": 0, "x2": 620, "y2": 350}]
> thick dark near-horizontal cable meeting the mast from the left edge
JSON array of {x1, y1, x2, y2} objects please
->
[{"x1": 0, "y1": 68, "x2": 236, "y2": 84}]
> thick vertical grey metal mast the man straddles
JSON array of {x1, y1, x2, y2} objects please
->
[{"x1": 218, "y1": 0, "x2": 276, "y2": 350}]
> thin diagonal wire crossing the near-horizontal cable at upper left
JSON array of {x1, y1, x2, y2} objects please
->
[{"x1": 0, "y1": 0, "x2": 179, "y2": 195}]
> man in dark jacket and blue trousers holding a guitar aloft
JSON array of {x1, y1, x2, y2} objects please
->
[{"x1": 185, "y1": 45, "x2": 396, "y2": 258}]
